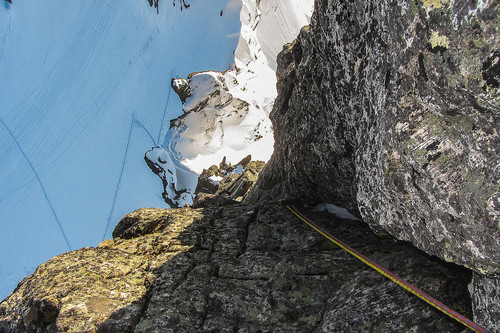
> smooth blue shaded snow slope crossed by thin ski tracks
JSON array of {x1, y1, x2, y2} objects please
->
[{"x1": 0, "y1": 0, "x2": 241, "y2": 299}]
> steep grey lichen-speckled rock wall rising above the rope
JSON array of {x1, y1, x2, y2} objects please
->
[{"x1": 249, "y1": 0, "x2": 500, "y2": 277}]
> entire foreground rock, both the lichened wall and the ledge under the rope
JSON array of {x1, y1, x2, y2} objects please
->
[{"x1": 0, "y1": 0, "x2": 500, "y2": 332}]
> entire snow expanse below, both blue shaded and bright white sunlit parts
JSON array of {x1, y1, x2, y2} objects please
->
[{"x1": 0, "y1": 0, "x2": 313, "y2": 299}]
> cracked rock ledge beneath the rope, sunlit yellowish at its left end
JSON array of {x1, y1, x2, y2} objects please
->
[{"x1": 0, "y1": 203, "x2": 471, "y2": 332}]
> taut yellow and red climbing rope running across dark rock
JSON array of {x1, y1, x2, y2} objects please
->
[{"x1": 285, "y1": 205, "x2": 491, "y2": 333}]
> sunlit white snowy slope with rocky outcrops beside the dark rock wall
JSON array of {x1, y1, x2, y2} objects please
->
[{"x1": 145, "y1": 0, "x2": 313, "y2": 206}]
